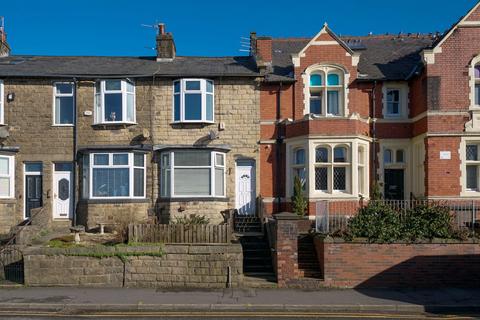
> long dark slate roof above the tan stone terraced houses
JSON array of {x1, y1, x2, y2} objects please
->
[{"x1": 0, "y1": 55, "x2": 259, "y2": 78}]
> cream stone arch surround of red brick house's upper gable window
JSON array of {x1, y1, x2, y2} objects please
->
[{"x1": 302, "y1": 62, "x2": 350, "y2": 117}]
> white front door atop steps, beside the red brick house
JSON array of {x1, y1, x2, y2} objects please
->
[{"x1": 235, "y1": 160, "x2": 256, "y2": 215}]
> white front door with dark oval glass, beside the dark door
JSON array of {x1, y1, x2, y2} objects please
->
[{"x1": 53, "y1": 165, "x2": 73, "y2": 219}]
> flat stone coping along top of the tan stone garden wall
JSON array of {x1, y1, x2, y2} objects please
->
[{"x1": 23, "y1": 243, "x2": 242, "y2": 255}]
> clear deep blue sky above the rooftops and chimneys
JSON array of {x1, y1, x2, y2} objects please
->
[{"x1": 0, "y1": 0, "x2": 477, "y2": 56}]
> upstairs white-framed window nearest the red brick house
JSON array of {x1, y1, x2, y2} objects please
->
[{"x1": 173, "y1": 79, "x2": 214, "y2": 123}]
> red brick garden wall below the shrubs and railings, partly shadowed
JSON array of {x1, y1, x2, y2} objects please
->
[{"x1": 315, "y1": 237, "x2": 480, "y2": 287}]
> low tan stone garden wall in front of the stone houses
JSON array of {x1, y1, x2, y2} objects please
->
[{"x1": 24, "y1": 244, "x2": 243, "y2": 288}]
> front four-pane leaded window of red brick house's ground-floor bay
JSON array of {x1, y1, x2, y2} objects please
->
[{"x1": 315, "y1": 145, "x2": 351, "y2": 193}]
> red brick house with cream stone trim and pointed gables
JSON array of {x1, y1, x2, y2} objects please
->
[{"x1": 252, "y1": 0, "x2": 480, "y2": 216}]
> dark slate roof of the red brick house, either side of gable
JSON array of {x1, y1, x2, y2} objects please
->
[{"x1": 266, "y1": 35, "x2": 435, "y2": 82}]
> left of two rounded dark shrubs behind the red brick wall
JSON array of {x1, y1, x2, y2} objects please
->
[{"x1": 345, "y1": 201, "x2": 402, "y2": 243}]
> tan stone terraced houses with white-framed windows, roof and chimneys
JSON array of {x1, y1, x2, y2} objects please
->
[{"x1": 0, "y1": 25, "x2": 260, "y2": 233}]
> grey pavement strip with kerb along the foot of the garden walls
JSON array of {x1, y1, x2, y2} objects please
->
[{"x1": 0, "y1": 287, "x2": 480, "y2": 316}]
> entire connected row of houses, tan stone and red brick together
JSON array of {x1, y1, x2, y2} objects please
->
[{"x1": 0, "y1": 4, "x2": 480, "y2": 233}]
